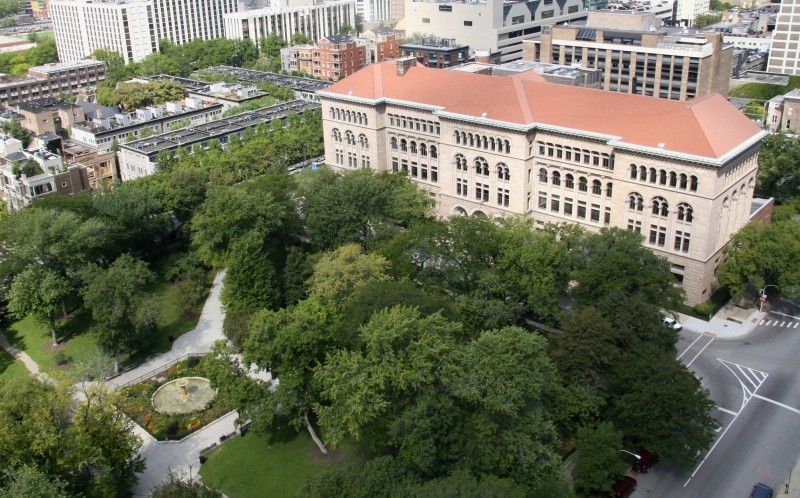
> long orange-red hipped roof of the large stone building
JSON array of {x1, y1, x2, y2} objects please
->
[{"x1": 325, "y1": 61, "x2": 762, "y2": 159}]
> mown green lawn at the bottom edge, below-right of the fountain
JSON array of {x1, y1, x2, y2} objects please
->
[{"x1": 200, "y1": 431, "x2": 364, "y2": 498}]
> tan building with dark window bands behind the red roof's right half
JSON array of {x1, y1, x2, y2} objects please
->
[{"x1": 523, "y1": 11, "x2": 733, "y2": 100}]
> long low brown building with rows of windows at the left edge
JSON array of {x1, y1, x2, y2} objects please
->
[{"x1": 0, "y1": 60, "x2": 106, "y2": 105}]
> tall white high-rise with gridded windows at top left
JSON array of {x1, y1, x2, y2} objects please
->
[{"x1": 50, "y1": 0, "x2": 238, "y2": 63}]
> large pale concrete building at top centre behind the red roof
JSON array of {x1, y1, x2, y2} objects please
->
[{"x1": 405, "y1": 0, "x2": 588, "y2": 62}]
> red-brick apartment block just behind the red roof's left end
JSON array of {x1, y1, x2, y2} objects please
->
[{"x1": 311, "y1": 35, "x2": 367, "y2": 81}]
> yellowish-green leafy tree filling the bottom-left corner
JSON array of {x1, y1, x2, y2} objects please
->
[{"x1": 0, "y1": 377, "x2": 144, "y2": 498}]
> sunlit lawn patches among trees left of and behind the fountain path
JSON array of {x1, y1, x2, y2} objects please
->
[{"x1": 5, "y1": 274, "x2": 206, "y2": 372}]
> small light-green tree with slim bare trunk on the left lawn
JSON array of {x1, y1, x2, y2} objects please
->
[{"x1": 7, "y1": 266, "x2": 72, "y2": 346}]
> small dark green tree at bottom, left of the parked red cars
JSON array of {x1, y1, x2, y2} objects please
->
[{"x1": 572, "y1": 422, "x2": 628, "y2": 494}]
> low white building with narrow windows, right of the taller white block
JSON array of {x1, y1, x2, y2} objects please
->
[{"x1": 224, "y1": 0, "x2": 356, "y2": 46}]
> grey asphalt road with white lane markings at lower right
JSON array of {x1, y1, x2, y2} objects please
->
[{"x1": 632, "y1": 303, "x2": 800, "y2": 498}]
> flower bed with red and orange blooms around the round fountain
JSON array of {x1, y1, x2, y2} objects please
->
[{"x1": 120, "y1": 357, "x2": 233, "y2": 441}]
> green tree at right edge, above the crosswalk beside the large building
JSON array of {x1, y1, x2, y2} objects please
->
[{"x1": 718, "y1": 220, "x2": 800, "y2": 296}]
